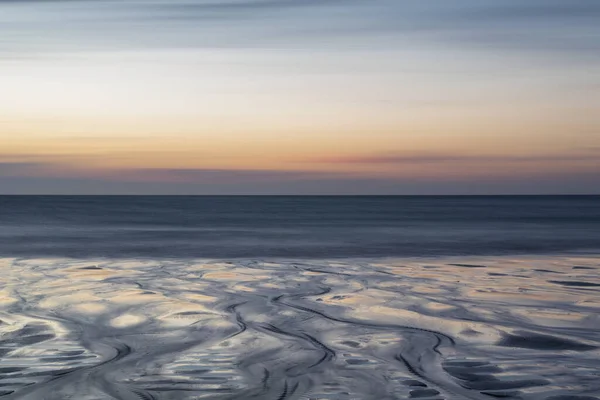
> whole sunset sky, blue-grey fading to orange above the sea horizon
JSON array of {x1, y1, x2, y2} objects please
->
[{"x1": 0, "y1": 0, "x2": 600, "y2": 194}]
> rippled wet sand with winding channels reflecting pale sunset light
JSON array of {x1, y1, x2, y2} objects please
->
[{"x1": 0, "y1": 256, "x2": 600, "y2": 400}]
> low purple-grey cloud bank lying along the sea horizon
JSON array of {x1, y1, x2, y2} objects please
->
[{"x1": 0, "y1": 173, "x2": 600, "y2": 195}]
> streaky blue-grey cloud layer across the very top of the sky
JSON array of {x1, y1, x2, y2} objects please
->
[{"x1": 0, "y1": 0, "x2": 600, "y2": 52}]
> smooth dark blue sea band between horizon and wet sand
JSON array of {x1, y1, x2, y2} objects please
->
[{"x1": 0, "y1": 196, "x2": 600, "y2": 258}]
